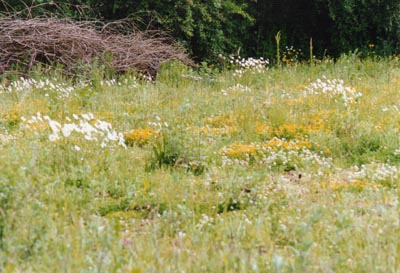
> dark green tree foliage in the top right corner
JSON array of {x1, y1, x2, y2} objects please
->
[{"x1": 328, "y1": 0, "x2": 400, "y2": 54}]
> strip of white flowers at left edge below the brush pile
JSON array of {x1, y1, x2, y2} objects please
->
[{"x1": 0, "y1": 78, "x2": 75, "y2": 98}]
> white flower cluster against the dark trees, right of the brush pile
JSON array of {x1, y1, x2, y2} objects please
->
[{"x1": 229, "y1": 56, "x2": 269, "y2": 78}]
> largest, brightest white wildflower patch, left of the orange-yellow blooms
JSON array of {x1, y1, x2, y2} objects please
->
[{"x1": 22, "y1": 113, "x2": 125, "y2": 148}]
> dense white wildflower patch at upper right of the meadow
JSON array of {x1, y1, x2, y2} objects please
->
[{"x1": 304, "y1": 76, "x2": 362, "y2": 106}]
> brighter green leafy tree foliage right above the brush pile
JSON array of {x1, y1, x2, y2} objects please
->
[{"x1": 85, "y1": 0, "x2": 253, "y2": 61}]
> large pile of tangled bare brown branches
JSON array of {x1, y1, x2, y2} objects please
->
[{"x1": 0, "y1": 18, "x2": 190, "y2": 78}]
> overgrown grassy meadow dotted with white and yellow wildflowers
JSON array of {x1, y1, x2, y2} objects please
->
[{"x1": 0, "y1": 55, "x2": 400, "y2": 273}]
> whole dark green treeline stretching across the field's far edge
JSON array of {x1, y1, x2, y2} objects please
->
[{"x1": 0, "y1": 0, "x2": 400, "y2": 61}]
